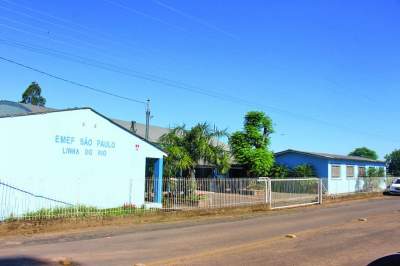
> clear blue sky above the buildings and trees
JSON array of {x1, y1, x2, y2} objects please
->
[{"x1": 0, "y1": 0, "x2": 400, "y2": 158}]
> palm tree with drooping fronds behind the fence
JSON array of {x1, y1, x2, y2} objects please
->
[{"x1": 160, "y1": 123, "x2": 230, "y2": 178}]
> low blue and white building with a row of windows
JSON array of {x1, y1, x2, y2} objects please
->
[{"x1": 275, "y1": 149, "x2": 386, "y2": 194}]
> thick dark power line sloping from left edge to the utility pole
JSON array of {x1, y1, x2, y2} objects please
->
[{"x1": 0, "y1": 56, "x2": 146, "y2": 104}]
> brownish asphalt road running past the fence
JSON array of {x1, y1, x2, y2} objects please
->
[{"x1": 0, "y1": 197, "x2": 400, "y2": 266}]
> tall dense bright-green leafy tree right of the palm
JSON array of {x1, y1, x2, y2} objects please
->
[{"x1": 229, "y1": 111, "x2": 274, "y2": 176}]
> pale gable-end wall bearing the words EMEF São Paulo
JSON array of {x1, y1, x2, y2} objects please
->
[{"x1": 0, "y1": 109, "x2": 165, "y2": 213}]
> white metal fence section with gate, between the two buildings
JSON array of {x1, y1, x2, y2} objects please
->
[{"x1": 146, "y1": 178, "x2": 322, "y2": 210}]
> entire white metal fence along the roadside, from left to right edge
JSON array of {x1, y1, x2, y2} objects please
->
[{"x1": 0, "y1": 177, "x2": 393, "y2": 222}]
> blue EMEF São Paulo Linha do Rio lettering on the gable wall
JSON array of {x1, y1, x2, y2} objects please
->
[{"x1": 54, "y1": 135, "x2": 116, "y2": 157}]
